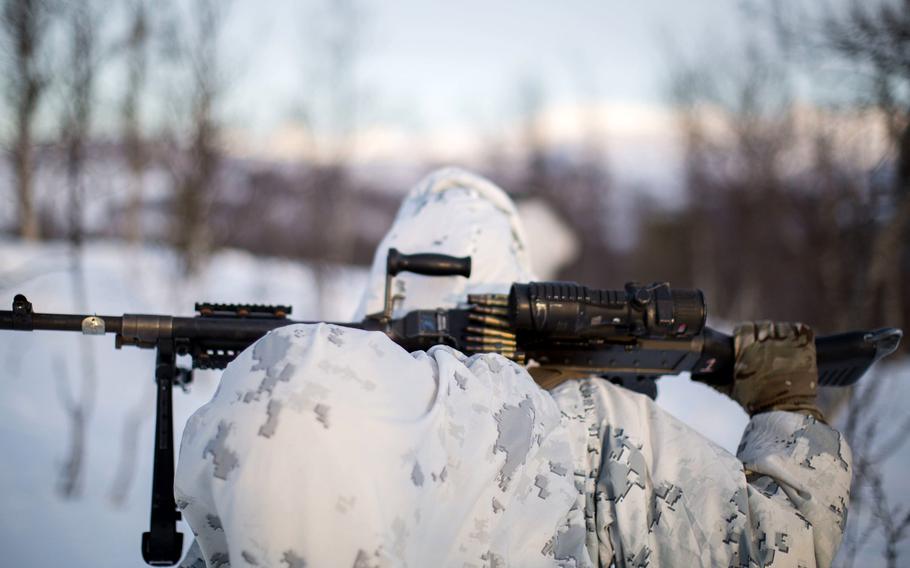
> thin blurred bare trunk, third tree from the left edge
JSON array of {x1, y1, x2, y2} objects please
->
[{"x1": 120, "y1": 0, "x2": 149, "y2": 244}]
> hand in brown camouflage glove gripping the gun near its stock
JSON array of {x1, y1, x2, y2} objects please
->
[{"x1": 726, "y1": 321, "x2": 824, "y2": 422}]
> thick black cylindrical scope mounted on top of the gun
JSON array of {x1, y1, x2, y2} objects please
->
[{"x1": 509, "y1": 282, "x2": 708, "y2": 340}]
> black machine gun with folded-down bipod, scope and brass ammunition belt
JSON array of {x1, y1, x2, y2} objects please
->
[{"x1": 0, "y1": 249, "x2": 902, "y2": 566}]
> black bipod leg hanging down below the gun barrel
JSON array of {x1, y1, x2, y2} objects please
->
[{"x1": 142, "y1": 339, "x2": 183, "y2": 566}]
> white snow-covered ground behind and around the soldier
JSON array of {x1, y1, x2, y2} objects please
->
[{"x1": 0, "y1": 237, "x2": 910, "y2": 568}]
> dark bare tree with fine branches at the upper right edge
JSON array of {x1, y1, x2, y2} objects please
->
[{"x1": 770, "y1": 0, "x2": 910, "y2": 338}]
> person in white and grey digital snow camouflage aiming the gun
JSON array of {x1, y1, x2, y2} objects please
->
[{"x1": 175, "y1": 169, "x2": 851, "y2": 568}]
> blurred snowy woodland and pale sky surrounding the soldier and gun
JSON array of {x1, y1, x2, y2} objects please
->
[{"x1": 0, "y1": 0, "x2": 910, "y2": 566}]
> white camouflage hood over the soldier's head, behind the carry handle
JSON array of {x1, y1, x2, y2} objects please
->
[{"x1": 355, "y1": 168, "x2": 533, "y2": 321}]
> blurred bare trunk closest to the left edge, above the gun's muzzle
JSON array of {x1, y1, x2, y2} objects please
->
[{"x1": 2, "y1": 0, "x2": 50, "y2": 239}]
